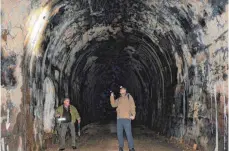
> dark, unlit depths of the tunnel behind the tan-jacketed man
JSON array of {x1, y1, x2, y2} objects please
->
[{"x1": 60, "y1": 33, "x2": 177, "y2": 130}]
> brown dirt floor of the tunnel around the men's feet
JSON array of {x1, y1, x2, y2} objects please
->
[{"x1": 47, "y1": 123, "x2": 192, "y2": 151}]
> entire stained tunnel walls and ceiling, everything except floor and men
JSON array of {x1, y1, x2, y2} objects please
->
[{"x1": 1, "y1": 0, "x2": 229, "y2": 151}]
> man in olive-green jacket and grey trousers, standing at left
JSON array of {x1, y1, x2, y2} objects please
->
[{"x1": 56, "y1": 98, "x2": 80, "y2": 150}]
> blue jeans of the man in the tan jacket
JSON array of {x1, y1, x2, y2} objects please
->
[{"x1": 117, "y1": 119, "x2": 134, "y2": 149}]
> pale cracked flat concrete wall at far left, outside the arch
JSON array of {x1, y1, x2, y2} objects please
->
[{"x1": 1, "y1": 0, "x2": 31, "y2": 151}]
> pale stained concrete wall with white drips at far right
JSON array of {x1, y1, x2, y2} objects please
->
[{"x1": 172, "y1": 2, "x2": 228, "y2": 150}]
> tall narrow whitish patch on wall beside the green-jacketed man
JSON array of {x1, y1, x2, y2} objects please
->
[{"x1": 43, "y1": 77, "x2": 56, "y2": 133}]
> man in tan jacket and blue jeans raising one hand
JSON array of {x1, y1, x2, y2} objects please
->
[{"x1": 110, "y1": 86, "x2": 136, "y2": 151}]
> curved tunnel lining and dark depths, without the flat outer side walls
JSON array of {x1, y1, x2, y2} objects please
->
[{"x1": 17, "y1": 0, "x2": 227, "y2": 150}]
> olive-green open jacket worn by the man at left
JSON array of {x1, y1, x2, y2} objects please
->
[{"x1": 56, "y1": 105, "x2": 80, "y2": 123}]
